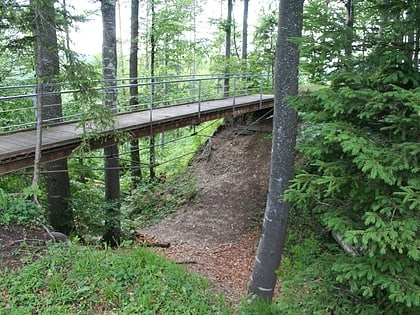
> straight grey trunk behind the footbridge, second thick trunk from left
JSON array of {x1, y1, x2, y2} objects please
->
[{"x1": 101, "y1": 0, "x2": 121, "y2": 246}]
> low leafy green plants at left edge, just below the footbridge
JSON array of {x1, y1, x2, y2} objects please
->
[{"x1": 0, "y1": 188, "x2": 42, "y2": 226}]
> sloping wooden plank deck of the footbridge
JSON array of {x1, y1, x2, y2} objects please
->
[{"x1": 0, "y1": 94, "x2": 274, "y2": 175}]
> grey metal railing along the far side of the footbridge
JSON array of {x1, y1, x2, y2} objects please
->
[{"x1": 0, "y1": 74, "x2": 272, "y2": 133}]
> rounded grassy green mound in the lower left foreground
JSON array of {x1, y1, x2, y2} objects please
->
[{"x1": 0, "y1": 245, "x2": 230, "y2": 314}]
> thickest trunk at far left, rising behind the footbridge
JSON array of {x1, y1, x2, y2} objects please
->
[{"x1": 30, "y1": 0, "x2": 73, "y2": 233}]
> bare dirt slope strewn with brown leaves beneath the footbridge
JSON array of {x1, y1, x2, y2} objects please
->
[{"x1": 141, "y1": 123, "x2": 271, "y2": 301}]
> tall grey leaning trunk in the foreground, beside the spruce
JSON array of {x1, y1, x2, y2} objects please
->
[{"x1": 249, "y1": 0, "x2": 304, "y2": 301}]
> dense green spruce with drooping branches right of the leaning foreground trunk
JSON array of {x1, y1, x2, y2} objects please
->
[{"x1": 282, "y1": 0, "x2": 420, "y2": 308}]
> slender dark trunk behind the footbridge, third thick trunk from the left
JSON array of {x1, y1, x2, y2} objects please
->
[{"x1": 130, "y1": 0, "x2": 142, "y2": 188}]
